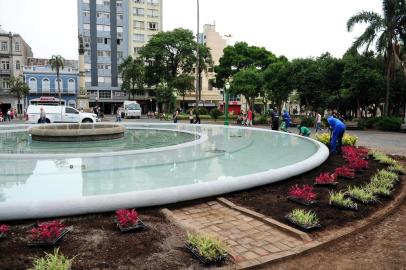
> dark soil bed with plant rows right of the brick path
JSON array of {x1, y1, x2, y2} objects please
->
[{"x1": 225, "y1": 155, "x2": 399, "y2": 235}]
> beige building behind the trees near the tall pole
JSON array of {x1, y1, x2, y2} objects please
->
[{"x1": 177, "y1": 24, "x2": 232, "y2": 109}]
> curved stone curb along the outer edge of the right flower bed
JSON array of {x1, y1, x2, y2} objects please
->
[{"x1": 244, "y1": 176, "x2": 406, "y2": 269}]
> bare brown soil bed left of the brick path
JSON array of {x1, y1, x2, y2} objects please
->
[{"x1": 0, "y1": 210, "x2": 216, "y2": 269}]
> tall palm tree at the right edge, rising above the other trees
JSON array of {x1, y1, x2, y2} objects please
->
[{"x1": 347, "y1": 0, "x2": 406, "y2": 116}]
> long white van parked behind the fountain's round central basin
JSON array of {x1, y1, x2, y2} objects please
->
[{"x1": 27, "y1": 105, "x2": 99, "y2": 124}]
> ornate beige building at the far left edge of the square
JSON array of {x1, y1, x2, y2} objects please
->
[{"x1": 0, "y1": 26, "x2": 32, "y2": 114}]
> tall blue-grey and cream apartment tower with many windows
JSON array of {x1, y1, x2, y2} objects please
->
[{"x1": 78, "y1": 0, "x2": 162, "y2": 113}]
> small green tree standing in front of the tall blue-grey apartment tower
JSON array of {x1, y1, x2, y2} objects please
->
[{"x1": 118, "y1": 56, "x2": 145, "y2": 100}]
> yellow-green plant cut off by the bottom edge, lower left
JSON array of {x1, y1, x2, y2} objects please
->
[{"x1": 31, "y1": 248, "x2": 74, "y2": 270}]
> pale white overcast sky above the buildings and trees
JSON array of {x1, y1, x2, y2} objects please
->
[{"x1": 0, "y1": 0, "x2": 382, "y2": 59}]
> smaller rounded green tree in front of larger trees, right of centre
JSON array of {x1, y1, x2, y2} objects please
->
[{"x1": 230, "y1": 67, "x2": 263, "y2": 108}]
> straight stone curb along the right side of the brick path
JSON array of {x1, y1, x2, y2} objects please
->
[{"x1": 217, "y1": 197, "x2": 312, "y2": 242}]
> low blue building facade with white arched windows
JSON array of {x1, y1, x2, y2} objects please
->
[{"x1": 23, "y1": 66, "x2": 79, "y2": 107}]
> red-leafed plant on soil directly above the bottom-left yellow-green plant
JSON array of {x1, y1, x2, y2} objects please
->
[{"x1": 28, "y1": 220, "x2": 65, "y2": 242}]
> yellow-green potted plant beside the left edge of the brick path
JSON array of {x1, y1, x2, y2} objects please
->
[{"x1": 186, "y1": 233, "x2": 228, "y2": 265}]
